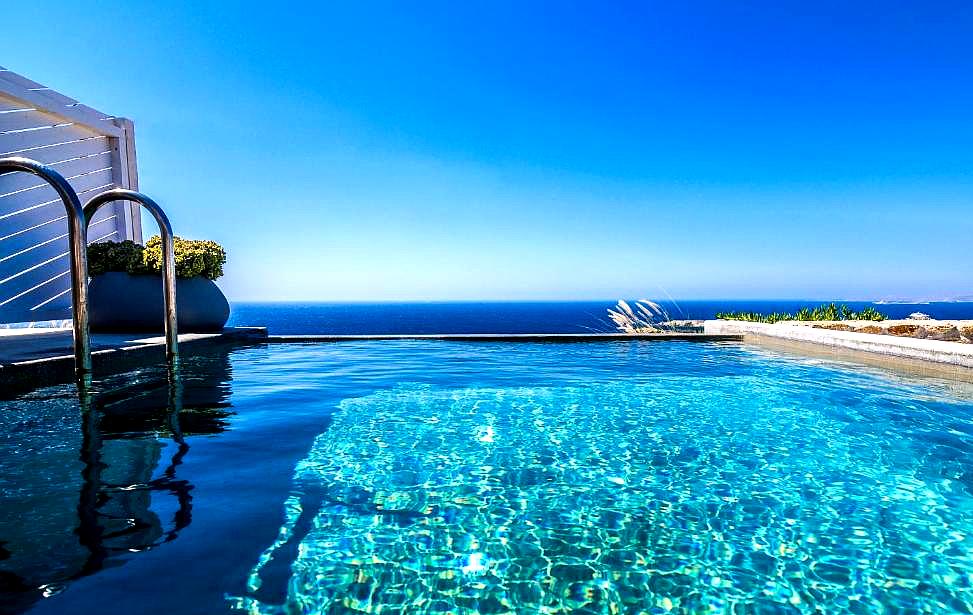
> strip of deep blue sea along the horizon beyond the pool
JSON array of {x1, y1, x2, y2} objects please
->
[{"x1": 229, "y1": 299, "x2": 973, "y2": 335}]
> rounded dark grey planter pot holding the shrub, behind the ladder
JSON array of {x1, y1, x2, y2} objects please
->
[{"x1": 88, "y1": 272, "x2": 230, "y2": 333}]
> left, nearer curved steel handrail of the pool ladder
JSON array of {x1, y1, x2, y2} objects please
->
[{"x1": 0, "y1": 157, "x2": 91, "y2": 376}]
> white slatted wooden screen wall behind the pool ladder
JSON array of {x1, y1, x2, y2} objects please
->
[{"x1": 0, "y1": 67, "x2": 142, "y2": 323}]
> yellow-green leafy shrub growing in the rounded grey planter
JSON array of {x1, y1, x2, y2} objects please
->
[{"x1": 88, "y1": 235, "x2": 226, "y2": 280}]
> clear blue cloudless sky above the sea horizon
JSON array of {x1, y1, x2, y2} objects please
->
[{"x1": 0, "y1": 0, "x2": 973, "y2": 300}]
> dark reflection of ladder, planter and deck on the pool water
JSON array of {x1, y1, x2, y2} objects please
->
[{"x1": 0, "y1": 352, "x2": 233, "y2": 613}]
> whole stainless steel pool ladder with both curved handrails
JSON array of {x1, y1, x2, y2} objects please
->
[{"x1": 0, "y1": 157, "x2": 179, "y2": 376}]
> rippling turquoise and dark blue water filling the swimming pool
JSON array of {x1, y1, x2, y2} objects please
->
[{"x1": 0, "y1": 341, "x2": 973, "y2": 614}]
